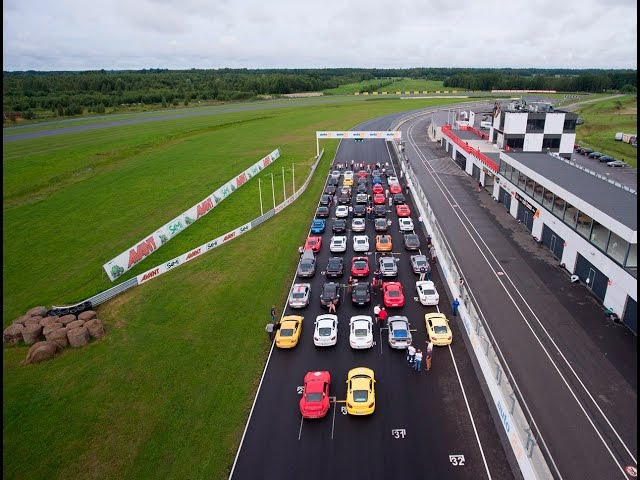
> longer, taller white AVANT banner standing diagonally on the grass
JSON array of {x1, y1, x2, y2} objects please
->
[{"x1": 102, "y1": 149, "x2": 280, "y2": 282}]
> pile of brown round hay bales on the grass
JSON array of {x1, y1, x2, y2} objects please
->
[{"x1": 3, "y1": 306, "x2": 105, "y2": 365}]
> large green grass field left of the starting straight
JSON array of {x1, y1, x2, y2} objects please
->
[{"x1": 3, "y1": 95, "x2": 470, "y2": 480}]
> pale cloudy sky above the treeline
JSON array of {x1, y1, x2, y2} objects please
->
[{"x1": 2, "y1": 0, "x2": 638, "y2": 71}]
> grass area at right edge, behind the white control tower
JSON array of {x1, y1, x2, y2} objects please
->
[{"x1": 576, "y1": 95, "x2": 638, "y2": 168}]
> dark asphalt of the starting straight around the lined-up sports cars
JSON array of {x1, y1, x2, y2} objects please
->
[{"x1": 231, "y1": 140, "x2": 513, "y2": 479}]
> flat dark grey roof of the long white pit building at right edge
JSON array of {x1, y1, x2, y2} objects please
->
[{"x1": 504, "y1": 152, "x2": 638, "y2": 232}]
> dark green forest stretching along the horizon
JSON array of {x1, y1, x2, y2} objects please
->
[{"x1": 2, "y1": 68, "x2": 637, "y2": 123}]
